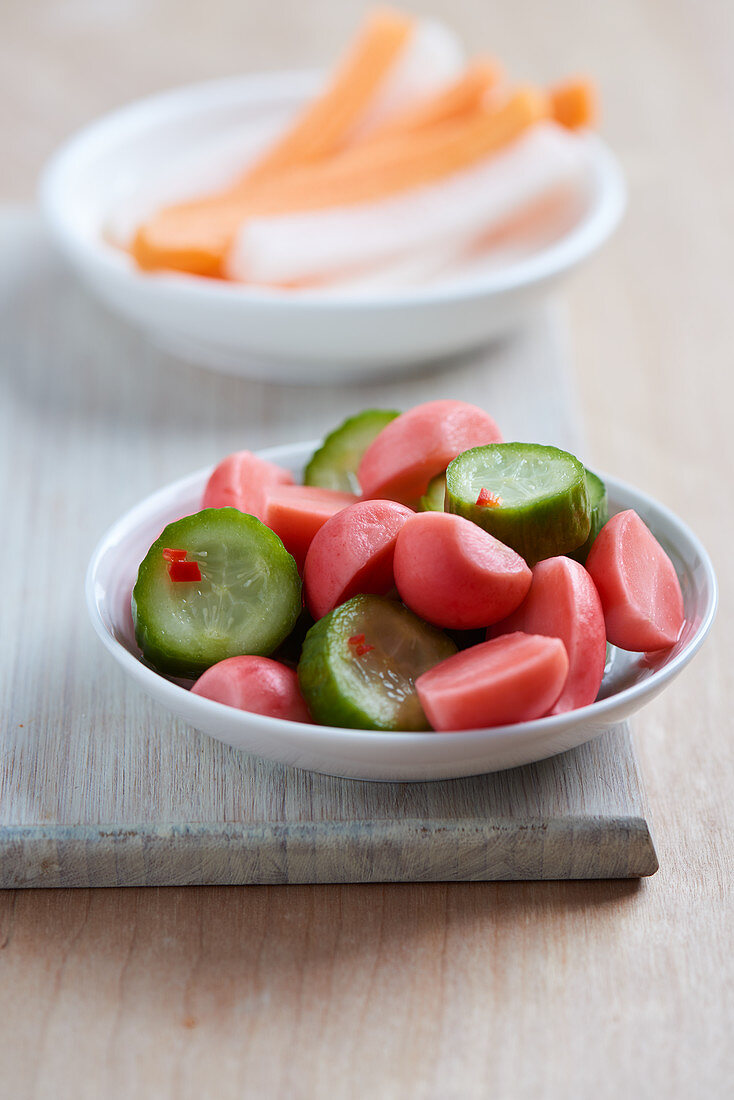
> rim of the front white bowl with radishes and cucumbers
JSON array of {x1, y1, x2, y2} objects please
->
[{"x1": 85, "y1": 441, "x2": 719, "y2": 751}]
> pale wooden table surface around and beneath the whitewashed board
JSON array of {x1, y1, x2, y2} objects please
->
[{"x1": 0, "y1": 0, "x2": 734, "y2": 1100}]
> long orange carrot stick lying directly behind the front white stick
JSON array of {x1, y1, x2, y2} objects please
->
[{"x1": 131, "y1": 88, "x2": 548, "y2": 275}]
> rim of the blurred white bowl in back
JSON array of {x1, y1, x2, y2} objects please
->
[{"x1": 39, "y1": 69, "x2": 627, "y2": 312}]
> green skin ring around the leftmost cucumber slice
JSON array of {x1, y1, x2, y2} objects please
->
[{"x1": 131, "y1": 508, "x2": 303, "y2": 680}]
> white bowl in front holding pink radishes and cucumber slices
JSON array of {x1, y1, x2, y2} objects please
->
[{"x1": 87, "y1": 443, "x2": 716, "y2": 781}]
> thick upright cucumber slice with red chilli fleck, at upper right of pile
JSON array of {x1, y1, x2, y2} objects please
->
[{"x1": 446, "y1": 443, "x2": 591, "y2": 565}]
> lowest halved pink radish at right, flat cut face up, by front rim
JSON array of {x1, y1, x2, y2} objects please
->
[{"x1": 416, "y1": 633, "x2": 568, "y2": 730}]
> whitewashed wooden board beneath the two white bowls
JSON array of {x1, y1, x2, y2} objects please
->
[{"x1": 0, "y1": 211, "x2": 657, "y2": 887}]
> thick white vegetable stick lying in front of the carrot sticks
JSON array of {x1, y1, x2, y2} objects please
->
[{"x1": 227, "y1": 122, "x2": 588, "y2": 284}]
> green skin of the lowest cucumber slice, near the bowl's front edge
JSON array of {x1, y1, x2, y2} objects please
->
[{"x1": 298, "y1": 596, "x2": 457, "y2": 733}]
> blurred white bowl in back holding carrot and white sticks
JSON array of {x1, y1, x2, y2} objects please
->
[{"x1": 41, "y1": 73, "x2": 625, "y2": 383}]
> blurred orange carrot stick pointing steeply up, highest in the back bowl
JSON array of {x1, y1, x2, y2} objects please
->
[{"x1": 242, "y1": 8, "x2": 415, "y2": 187}]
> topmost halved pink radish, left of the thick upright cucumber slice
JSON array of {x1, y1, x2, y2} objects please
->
[{"x1": 358, "y1": 400, "x2": 502, "y2": 504}]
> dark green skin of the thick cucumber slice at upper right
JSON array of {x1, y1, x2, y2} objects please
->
[{"x1": 446, "y1": 443, "x2": 591, "y2": 569}]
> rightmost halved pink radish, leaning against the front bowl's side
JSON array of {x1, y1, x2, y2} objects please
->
[{"x1": 587, "y1": 508, "x2": 684, "y2": 652}]
